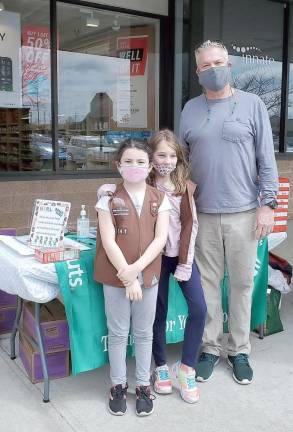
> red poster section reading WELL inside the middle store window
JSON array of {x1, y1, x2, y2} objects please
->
[{"x1": 117, "y1": 36, "x2": 149, "y2": 76}]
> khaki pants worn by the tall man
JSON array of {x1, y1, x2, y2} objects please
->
[{"x1": 195, "y1": 209, "x2": 257, "y2": 356}]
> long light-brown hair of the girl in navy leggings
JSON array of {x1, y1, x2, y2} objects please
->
[{"x1": 148, "y1": 129, "x2": 189, "y2": 195}]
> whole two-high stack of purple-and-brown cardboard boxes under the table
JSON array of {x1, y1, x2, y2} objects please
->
[{"x1": 19, "y1": 299, "x2": 69, "y2": 383}]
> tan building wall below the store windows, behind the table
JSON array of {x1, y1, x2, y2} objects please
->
[{"x1": 0, "y1": 160, "x2": 293, "y2": 234}]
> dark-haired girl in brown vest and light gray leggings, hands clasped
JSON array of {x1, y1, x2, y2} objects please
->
[{"x1": 95, "y1": 139, "x2": 170, "y2": 416}]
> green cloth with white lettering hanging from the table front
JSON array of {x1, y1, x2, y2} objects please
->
[{"x1": 55, "y1": 236, "x2": 268, "y2": 375}]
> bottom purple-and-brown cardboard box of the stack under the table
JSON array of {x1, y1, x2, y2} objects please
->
[{"x1": 19, "y1": 331, "x2": 70, "y2": 383}]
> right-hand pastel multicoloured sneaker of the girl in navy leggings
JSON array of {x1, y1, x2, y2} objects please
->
[{"x1": 172, "y1": 361, "x2": 199, "y2": 403}]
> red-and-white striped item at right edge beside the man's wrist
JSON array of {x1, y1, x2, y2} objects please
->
[{"x1": 273, "y1": 177, "x2": 290, "y2": 233}]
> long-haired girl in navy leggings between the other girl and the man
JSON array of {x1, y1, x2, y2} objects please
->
[{"x1": 149, "y1": 130, "x2": 206, "y2": 403}]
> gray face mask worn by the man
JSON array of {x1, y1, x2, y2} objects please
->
[{"x1": 198, "y1": 66, "x2": 230, "y2": 91}]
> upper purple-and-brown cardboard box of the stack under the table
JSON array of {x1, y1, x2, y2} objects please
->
[{"x1": 22, "y1": 299, "x2": 70, "y2": 352}]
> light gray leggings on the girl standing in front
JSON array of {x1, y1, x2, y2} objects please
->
[{"x1": 104, "y1": 285, "x2": 158, "y2": 386}]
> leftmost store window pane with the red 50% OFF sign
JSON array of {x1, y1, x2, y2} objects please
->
[{"x1": 0, "y1": 0, "x2": 52, "y2": 171}]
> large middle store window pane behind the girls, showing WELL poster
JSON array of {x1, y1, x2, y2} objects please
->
[{"x1": 57, "y1": 2, "x2": 159, "y2": 171}]
